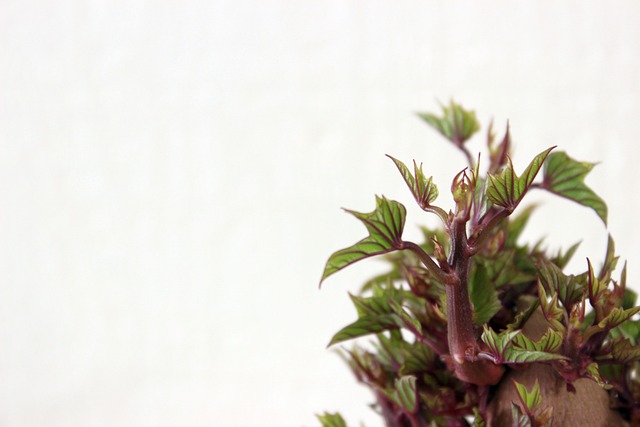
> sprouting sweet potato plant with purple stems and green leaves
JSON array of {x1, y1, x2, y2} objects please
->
[{"x1": 318, "y1": 102, "x2": 640, "y2": 427}]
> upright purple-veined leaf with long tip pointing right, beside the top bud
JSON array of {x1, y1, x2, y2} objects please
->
[{"x1": 487, "y1": 147, "x2": 555, "y2": 210}]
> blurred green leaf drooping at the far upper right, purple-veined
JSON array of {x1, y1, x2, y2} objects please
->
[{"x1": 542, "y1": 152, "x2": 607, "y2": 224}]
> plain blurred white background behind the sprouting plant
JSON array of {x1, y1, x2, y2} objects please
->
[{"x1": 0, "y1": 0, "x2": 640, "y2": 427}]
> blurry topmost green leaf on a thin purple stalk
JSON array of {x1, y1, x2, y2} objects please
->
[{"x1": 418, "y1": 101, "x2": 480, "y2": 145}]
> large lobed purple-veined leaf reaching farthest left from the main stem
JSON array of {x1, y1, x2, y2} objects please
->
[{"x1": 320, "y1": 196, "x2": 407, "y2": 284}]
